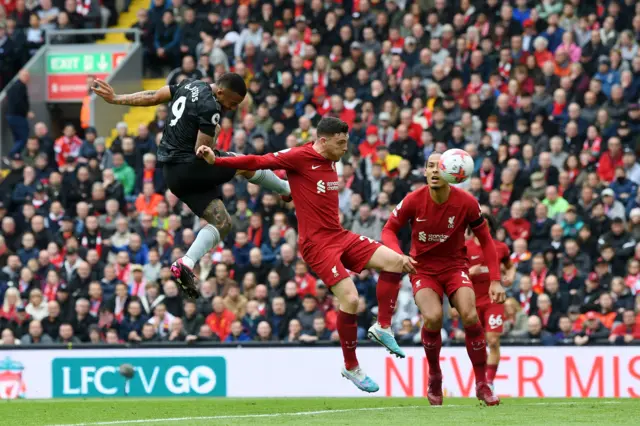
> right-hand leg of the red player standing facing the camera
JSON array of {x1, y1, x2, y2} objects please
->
[{"x1": 443, "y1": 271, "x2": 500, "y2": 405}]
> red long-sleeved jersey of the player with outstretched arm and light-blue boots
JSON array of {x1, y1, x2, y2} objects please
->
[{"x1": 215, "y1": 142, "x2": 343, "y2": 245}]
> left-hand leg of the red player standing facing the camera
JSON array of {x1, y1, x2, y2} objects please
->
[{"x1": 411, "y1": 275, "x2": 443, "y2": 405}]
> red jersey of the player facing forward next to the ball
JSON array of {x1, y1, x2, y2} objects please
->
[{"x1": 382, "y1": 186, "x2": 484, "y2": 274}]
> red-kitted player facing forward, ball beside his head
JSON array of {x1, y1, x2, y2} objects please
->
[{"x1": 382, "y1": 153, "x2": 505, "y2": 405}]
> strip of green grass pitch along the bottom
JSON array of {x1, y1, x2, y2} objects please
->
[{"x1": 0, "y1": 398, "x2": 640, "y2": 426}]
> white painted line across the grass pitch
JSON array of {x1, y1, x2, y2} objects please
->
[{"x1": 50, "y1": 400, "x2": 620, "y2": 426}]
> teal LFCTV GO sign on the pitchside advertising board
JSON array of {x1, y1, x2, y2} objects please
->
[{"x1": 52, "y1": 357, "x2": 227, "y2": 398}]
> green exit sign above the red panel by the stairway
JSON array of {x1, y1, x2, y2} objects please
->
[{"x1": 47, "y1": 53, "x2": 126, "y2": 74}]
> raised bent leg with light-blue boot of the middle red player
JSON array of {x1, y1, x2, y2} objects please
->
[{"x1": 366, "y1": 245, "x2": 405, "y2": 358}]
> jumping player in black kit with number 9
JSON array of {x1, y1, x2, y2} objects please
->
[{"x1": 93, "y1": 73, "x2": 291, "y2": 298}]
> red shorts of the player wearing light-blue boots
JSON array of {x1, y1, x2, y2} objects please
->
[{"x1": 300, "y1": 231, "x2": 380, "y2": 287}]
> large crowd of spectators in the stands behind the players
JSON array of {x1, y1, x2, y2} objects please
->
[{"x1": 0, "y1": 0, "x2": 640, "y2": 345}]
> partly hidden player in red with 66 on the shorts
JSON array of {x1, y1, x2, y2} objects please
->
[{"x1": 465, "y1": 214, "x2": 515, "y2": 387}]
